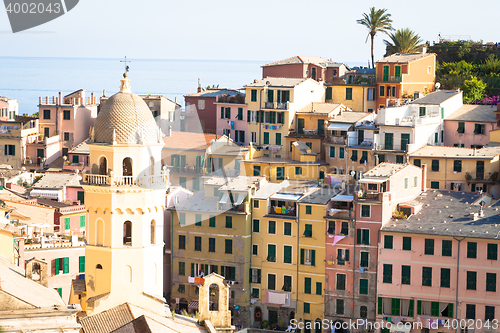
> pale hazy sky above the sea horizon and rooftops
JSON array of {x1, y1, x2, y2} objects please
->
[{"x1": 0, "y1": 0, "x2": 500, "y2": 63}]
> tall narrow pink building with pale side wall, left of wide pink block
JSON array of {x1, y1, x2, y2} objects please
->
[{"x1": 325, "y1": 163, "x2": 425, "y2": 322}]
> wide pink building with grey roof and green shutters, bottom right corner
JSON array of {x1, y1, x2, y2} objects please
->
[{"x1": 377, "y1": 190, "x2": 500, "y2": 332}]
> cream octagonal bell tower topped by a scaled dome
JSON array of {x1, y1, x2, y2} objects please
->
[{"x1": 83, "y1": 73, "x2": 169, "y2": 315}]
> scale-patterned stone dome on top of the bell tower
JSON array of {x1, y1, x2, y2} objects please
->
[{"x1": 93, "y1": 76, "x2": 158, "y2": 144}]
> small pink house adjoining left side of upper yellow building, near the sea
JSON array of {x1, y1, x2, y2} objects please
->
[{"x1": 216, "y1": 98, "x2": 248, "y2": 146}]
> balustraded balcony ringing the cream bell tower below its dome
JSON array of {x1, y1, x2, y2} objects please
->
[{"x1": 83, "y1": 173, "x2": 168, "y2": 187}]
